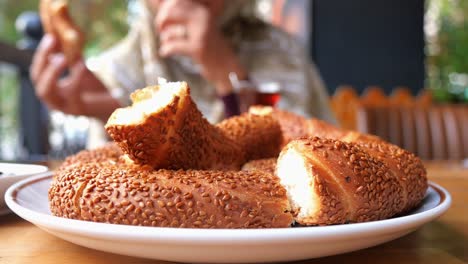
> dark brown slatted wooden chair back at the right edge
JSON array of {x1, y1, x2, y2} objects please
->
[{"x1": 357, "y1": 104, "x2": 468, "y2": 160}]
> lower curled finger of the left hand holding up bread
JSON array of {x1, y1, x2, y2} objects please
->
[{"x1": 35, "y1": 54, "x2": 67, "y2": 108}]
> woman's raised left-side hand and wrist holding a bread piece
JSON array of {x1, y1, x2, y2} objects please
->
[{"x1": 30, "y1": 34, "x2": 119, "y2": 120}]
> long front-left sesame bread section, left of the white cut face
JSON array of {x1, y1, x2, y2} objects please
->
[{"x1": 49, "y1": 163, "x2": 292, "y2": 228}]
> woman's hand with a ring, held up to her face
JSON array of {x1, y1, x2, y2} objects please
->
[{"x1": 155, "y1": 0, "x2": 246, "y2": 95}]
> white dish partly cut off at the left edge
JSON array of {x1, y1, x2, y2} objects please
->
[{"x1": 0, "y1": 163, "x2": 48, "y2": 215}]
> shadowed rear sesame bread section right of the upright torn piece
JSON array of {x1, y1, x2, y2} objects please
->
[{"x1": 216, "y1": 113, "x2": 283, "y2": 161}]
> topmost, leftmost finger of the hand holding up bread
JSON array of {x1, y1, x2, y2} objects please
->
[{"x1": 30, "y1": 34, "x2": 57, "y2": 83}]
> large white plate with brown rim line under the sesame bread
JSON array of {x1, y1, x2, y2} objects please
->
[{"x1": 5, "y1": 175, "x2": 451, "y2": 263}]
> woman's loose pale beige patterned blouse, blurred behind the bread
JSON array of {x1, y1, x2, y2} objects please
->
[{"x1": 90, "y1": 1, "x2": 336, "y2": 123}]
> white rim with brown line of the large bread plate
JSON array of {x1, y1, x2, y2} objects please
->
[{"x1": 5, "y1": 171, "x2": 452, "y2": 245}]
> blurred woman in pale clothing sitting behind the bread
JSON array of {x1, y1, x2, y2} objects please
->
[{"x1": 31, "y1": 0, "x2": 334, "y2": 144}]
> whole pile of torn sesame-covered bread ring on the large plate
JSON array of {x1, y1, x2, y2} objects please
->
[{"x1": 49, "y1": 91, "x2": 428, "y2": 228}]
